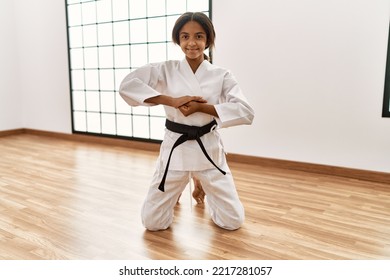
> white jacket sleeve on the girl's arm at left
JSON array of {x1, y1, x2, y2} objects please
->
[{"x1": 119, "y1": 64, "x2": 161, "y2": 106}]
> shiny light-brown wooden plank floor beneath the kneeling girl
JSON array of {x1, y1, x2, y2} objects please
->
[{"x1": 0, "y1": 134, "x2": 390, "y2": 260}]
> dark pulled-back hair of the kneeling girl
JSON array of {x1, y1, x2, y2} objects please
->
[{"x1": 172, "y1": 12, "x2": 215, "y2": 59}]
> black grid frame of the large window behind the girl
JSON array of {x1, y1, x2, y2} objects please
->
[{"x1": 64, "y1": 0, "x2": 212, "y2": 143}]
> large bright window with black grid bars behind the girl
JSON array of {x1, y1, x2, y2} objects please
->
[{"x1": 66, "y1": 0, "x2": 211, "y2": 141}]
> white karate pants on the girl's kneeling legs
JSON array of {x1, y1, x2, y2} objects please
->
[{"x1": 141, "y1": 164, "x2": 245, "y2": 231}]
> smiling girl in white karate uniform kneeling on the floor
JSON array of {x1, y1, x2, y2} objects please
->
[{"x1": 119, "y1": 12, "x2": 254, "y2": 231}]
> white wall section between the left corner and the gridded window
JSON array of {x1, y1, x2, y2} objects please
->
[{"x1": 12, "y1": 0, "x2": 72, "y2": 133}]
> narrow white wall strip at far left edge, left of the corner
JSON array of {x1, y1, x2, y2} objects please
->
[{"x1": 0, "y1": 0, "x2": 23, "y2": 131}]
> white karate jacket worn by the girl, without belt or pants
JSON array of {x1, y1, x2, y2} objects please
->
[{"x1": 119, "y1": 59, "x2": 254, "y2": 172}]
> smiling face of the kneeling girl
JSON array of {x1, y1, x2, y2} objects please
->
[{"x1": 179, "y1": 21, "x2": 207, "y2": 61}]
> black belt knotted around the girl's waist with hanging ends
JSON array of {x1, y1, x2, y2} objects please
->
[{"x1": 158, "y1": 119, "x2": 226, "y2": 192}]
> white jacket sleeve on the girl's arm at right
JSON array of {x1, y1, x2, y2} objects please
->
[{"x1": 214, "y1": 72, "x2": 254, "y2": 128}]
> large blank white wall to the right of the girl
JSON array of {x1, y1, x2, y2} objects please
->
[{"x1": 213, "y1": 0, "x2": 390, "y2": 172}]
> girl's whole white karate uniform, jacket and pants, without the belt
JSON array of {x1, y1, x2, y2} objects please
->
[{"x1": 119, "y1": 59, "x2": 254, "y2": 230}]
